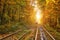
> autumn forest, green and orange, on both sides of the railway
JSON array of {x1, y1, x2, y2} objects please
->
[{"x1": 0, "y1": 0, "x2": 60, "y2": 40}]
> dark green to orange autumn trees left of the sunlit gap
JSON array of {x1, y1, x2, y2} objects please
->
[{"x1": 0, "y1": 0, "x2": 32, "y2": 33}]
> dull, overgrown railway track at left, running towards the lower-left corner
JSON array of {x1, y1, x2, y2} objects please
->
[{"x1": 0, "y1": 30, "x2": 30, "y2": 40}]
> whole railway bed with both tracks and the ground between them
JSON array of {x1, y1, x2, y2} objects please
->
[{"x1": 0, "y1": 27, "x2": 55, "y2": 40}]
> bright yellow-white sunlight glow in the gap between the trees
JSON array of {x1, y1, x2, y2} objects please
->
[{"x1": 31, "y1": 0, "x2": 42, "y2": 24}]
